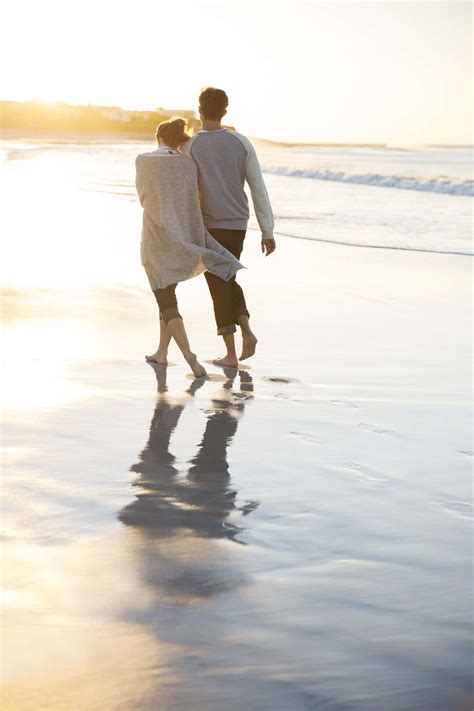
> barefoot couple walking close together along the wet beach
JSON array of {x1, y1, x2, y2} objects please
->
[{"x1": 136, "y1": 87, "x2": 275, "y2": 377}]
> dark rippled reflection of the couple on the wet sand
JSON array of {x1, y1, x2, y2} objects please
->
[{"x1": 119, "y1": 366, "x2": 258, "y2": 540}]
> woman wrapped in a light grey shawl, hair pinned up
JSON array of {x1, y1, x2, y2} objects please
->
[{"x1": 136, "y1": 118, "x2": 242, "y2": 378}]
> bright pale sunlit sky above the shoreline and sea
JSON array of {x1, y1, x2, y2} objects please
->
[{"x1": 0, "y1": 0, "x2": 472, "y2": 144}]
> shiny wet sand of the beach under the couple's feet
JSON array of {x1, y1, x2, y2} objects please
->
[{"x1": 2, "y1": 239, "x2": 472, "y2": 711}]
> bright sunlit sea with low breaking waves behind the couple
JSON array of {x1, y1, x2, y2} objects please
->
[{"x1": 0, "y1": 139, "x2": 474, "y2": 287}]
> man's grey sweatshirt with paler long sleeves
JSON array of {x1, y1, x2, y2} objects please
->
[{"x1": 181, "y1": 128, "x2": 274, "y2": 239}]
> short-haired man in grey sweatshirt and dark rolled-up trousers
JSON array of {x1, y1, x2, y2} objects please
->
[{"x1": 181, "y1": 87, "x2": 276, "y2": 368}]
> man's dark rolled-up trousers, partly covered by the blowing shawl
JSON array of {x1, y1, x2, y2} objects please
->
[{"x1": 205, "y1": 229, "x2": 250, "y2": 336}]
